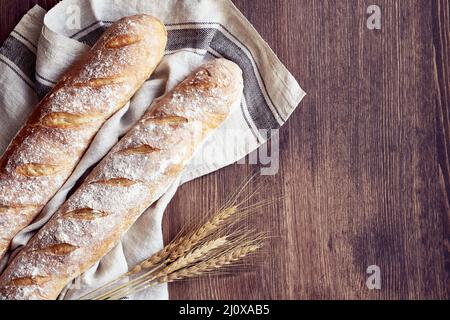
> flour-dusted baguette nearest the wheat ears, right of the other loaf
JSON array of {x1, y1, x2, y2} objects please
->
[{"x1": 0, "y1": 59, "x2": 243, "y2": 299}]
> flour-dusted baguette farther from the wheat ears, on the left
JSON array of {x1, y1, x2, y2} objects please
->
[{"x1": 0, "y1": 15, "x2": 167, "y2": 258}]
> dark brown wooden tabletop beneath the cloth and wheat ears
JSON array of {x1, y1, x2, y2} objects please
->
[{"x1": 0, "y1": 0, "x2": 450, "y2": 299}]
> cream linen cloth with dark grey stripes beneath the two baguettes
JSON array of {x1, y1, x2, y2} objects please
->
[{"x1": 0, "y1": 0, "x2": 305, "y2": 299}]
